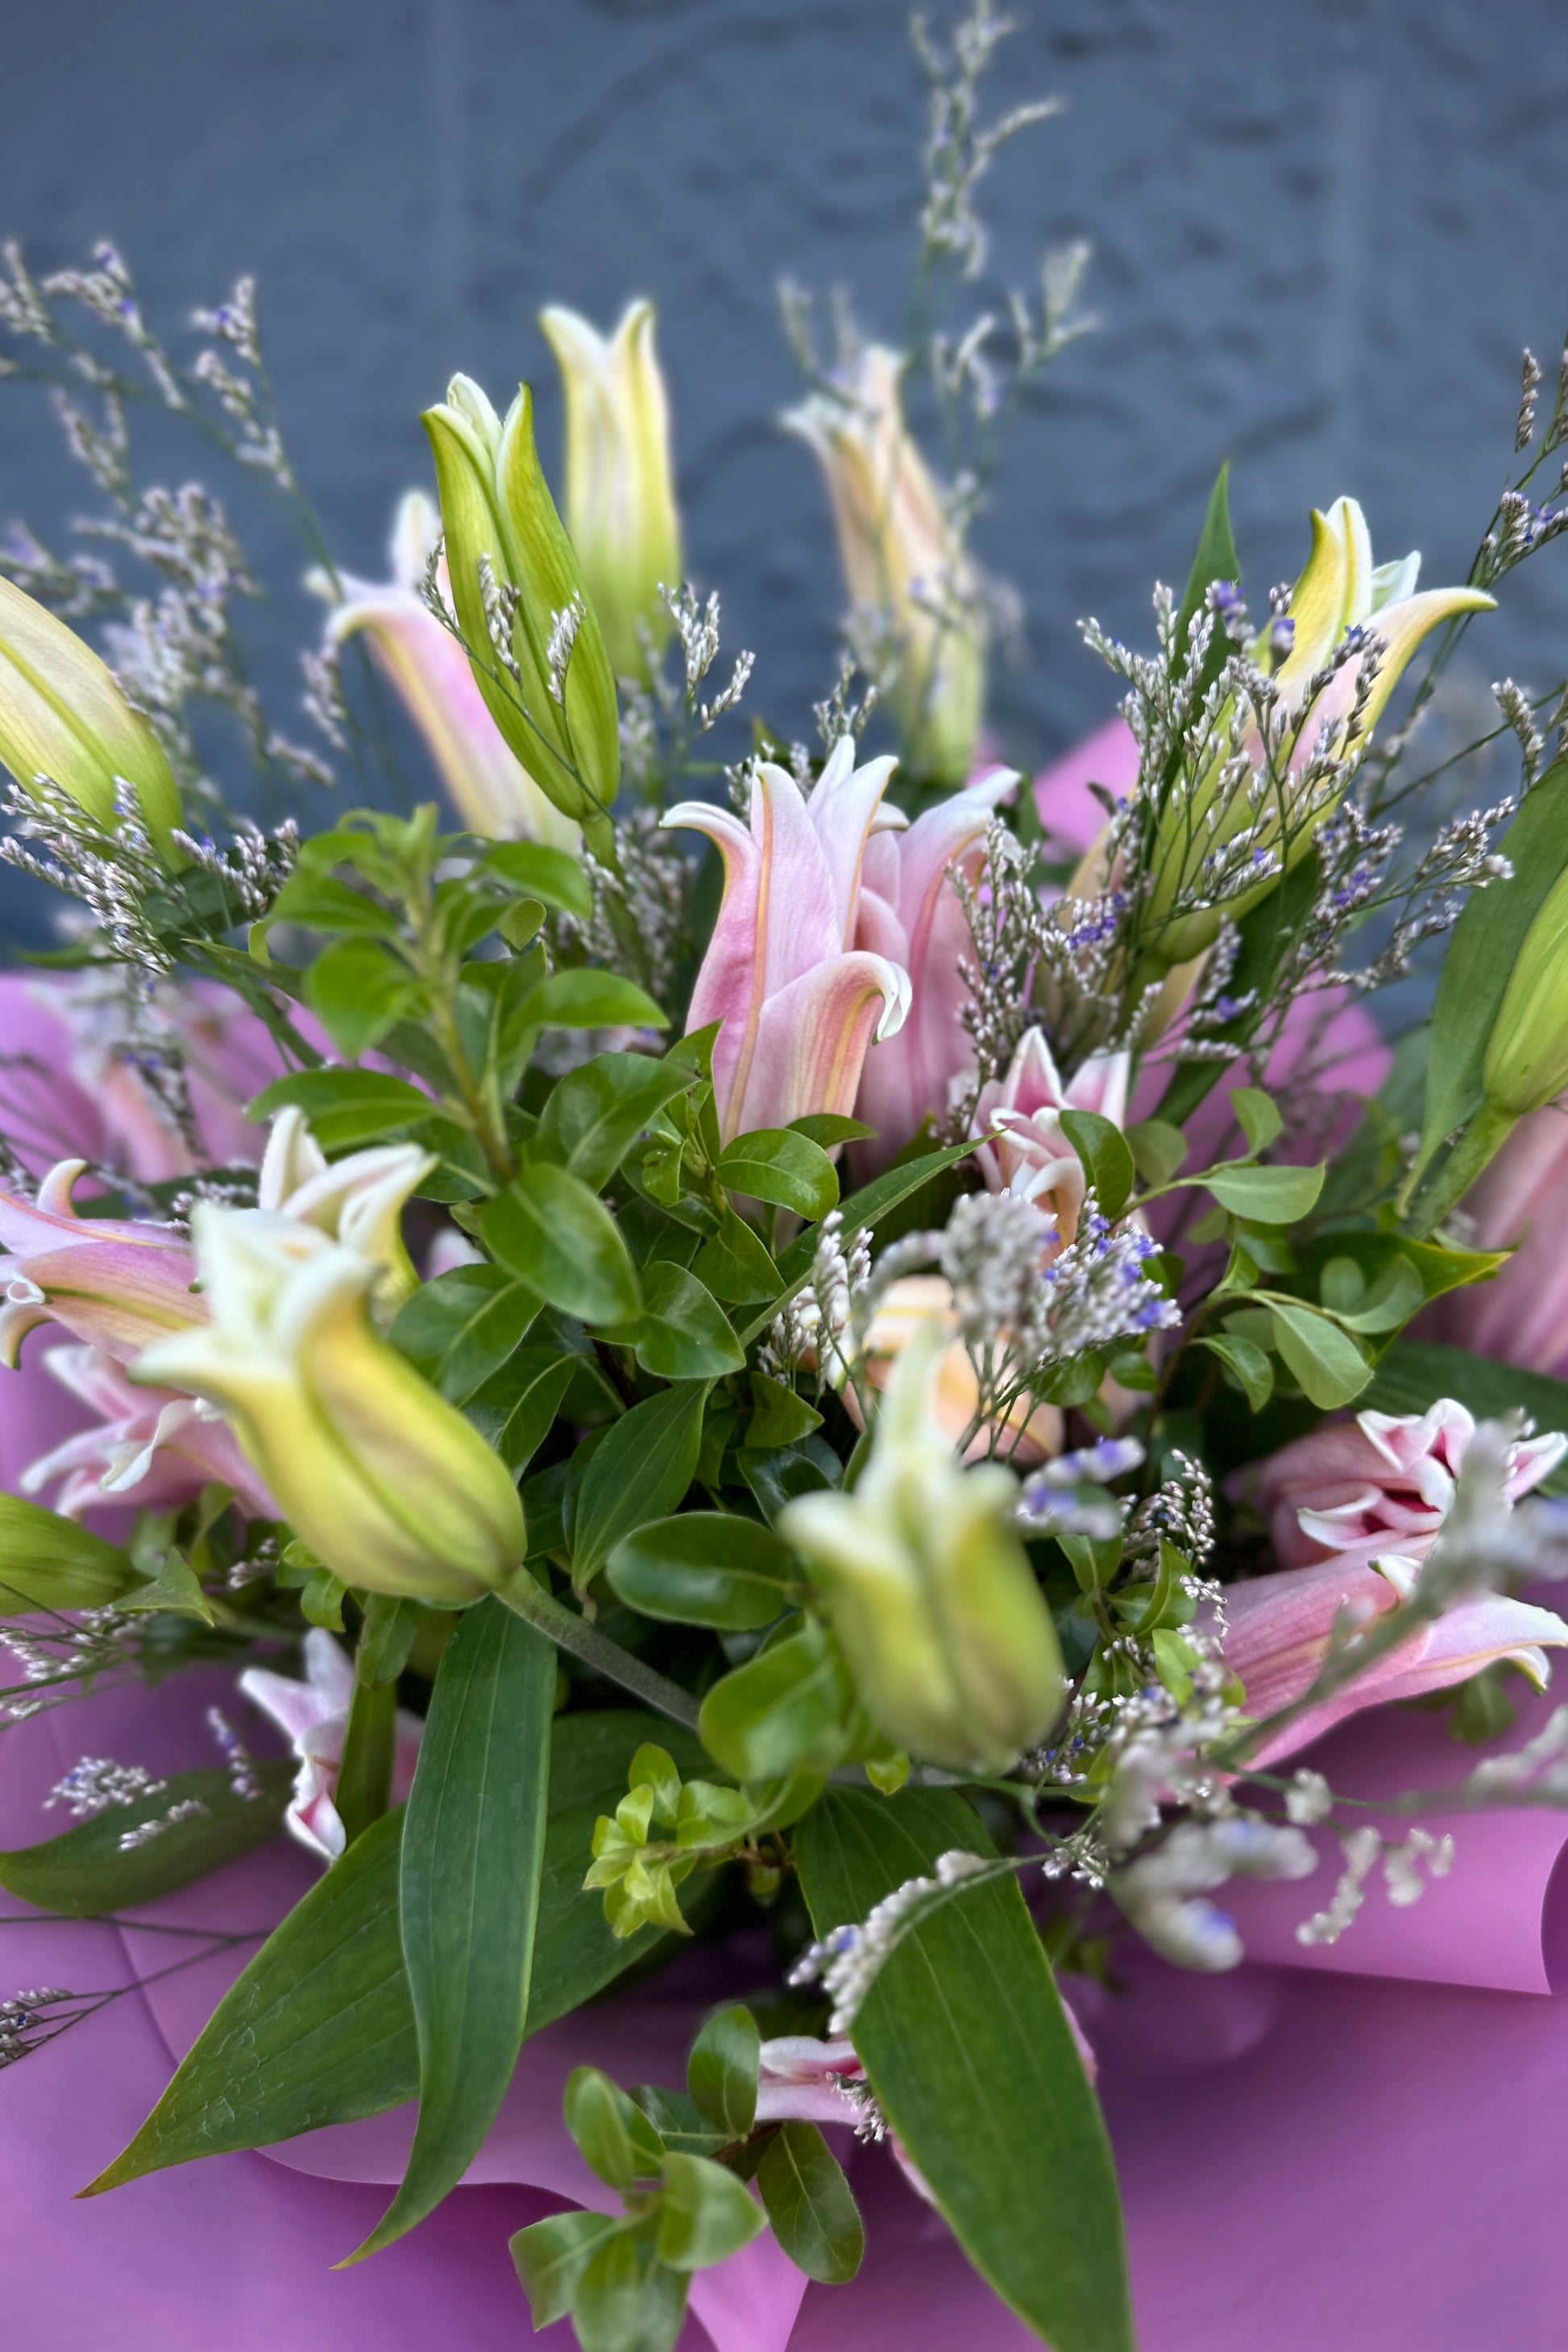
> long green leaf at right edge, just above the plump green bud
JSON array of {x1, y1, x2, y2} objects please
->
[{"x1": 1415, "y1": 760, "x2": 1568, "y2": 1169}]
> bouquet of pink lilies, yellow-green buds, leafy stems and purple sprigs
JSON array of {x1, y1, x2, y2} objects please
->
[{"x1": 0, "y1": 0, "x2": 1568, "y2": 2352}]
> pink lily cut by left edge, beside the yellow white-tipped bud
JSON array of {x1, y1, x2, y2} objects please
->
[{"x1": 0, "y1": 1159, "x2": 207, "y2": 1369}]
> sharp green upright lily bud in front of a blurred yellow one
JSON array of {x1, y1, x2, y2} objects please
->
[{"x1": 423, "y1": 376, "x2": 620, "y2": 861}]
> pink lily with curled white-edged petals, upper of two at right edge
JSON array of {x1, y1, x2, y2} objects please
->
[{"x1": 1251, "y1": 1397, "x2": 1568, "y2": 1569}]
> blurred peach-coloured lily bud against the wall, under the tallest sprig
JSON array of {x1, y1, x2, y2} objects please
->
[{"x1": 783, "y1": 343, "x2": 987, "y2": 783}]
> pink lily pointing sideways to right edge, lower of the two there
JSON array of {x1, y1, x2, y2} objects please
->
[{"x1": 1225, "y1": 1554, "x2": 1568, "y2": 1766}]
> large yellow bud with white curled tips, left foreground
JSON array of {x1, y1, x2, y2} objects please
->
[{"x1": 134, "y1": 1202, "x2": 525, "y2": 1607}]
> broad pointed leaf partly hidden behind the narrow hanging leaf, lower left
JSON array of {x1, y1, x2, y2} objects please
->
[{"x1": 82, "y1": 1707, "x2": 705, "y2": 2188}]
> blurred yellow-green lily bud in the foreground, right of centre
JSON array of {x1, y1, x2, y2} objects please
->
[{"x1": 778, "y1": 1321, "x2": 1063, "y2": 1773}]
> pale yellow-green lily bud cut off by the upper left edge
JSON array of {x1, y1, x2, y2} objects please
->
[{"x1": 0, "y1": 579, "x2": 184, "y2": 865}]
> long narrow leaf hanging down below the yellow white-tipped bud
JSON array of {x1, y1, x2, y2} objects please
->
[{"x1": 359, "y1": 1599, "x2": 555, "y2": 2255}]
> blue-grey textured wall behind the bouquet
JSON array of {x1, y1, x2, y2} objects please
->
[{"x1": 0, "y1": 0, "x2": 1568, "y2": 936}]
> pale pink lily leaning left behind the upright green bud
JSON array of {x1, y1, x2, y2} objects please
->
[{"x1": 308, "y1": 489, "x2": 579, "y2": 849}]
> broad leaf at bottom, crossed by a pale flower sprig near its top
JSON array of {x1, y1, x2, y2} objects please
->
[{"x1": 794, "y1": 1787, "x2": 1133, "y2": 2352}]
